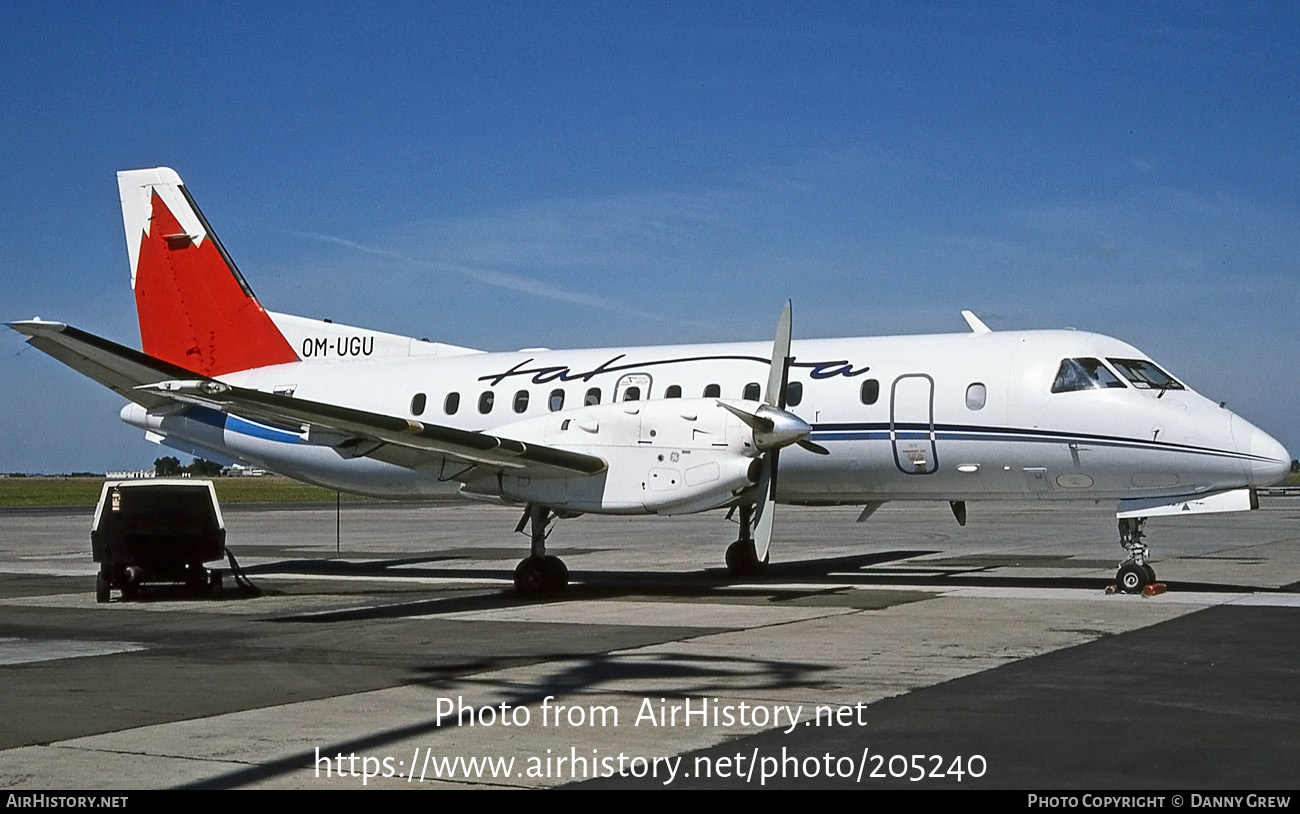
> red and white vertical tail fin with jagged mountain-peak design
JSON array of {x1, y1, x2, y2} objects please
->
[{"x1": 117, "y1": 166, "x2": 298, "y2": 376}]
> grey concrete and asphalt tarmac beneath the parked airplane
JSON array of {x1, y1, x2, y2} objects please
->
[{"x1": 0, "y1": 498, "x2": 1300, "y2": 791}]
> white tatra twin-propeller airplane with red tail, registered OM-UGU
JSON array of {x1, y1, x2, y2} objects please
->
[{"x1": 12, "y1": 168, "x2": 1290, "y2": 596}]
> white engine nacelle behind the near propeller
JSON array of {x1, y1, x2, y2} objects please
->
[{"x1": 462, "y1": 399, "x2": 761, "y2": 515}]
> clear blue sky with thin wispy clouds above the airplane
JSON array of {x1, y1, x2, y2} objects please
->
[{"x1": 0, "y1": 3, "x2": 1300, "y2": 472}]
